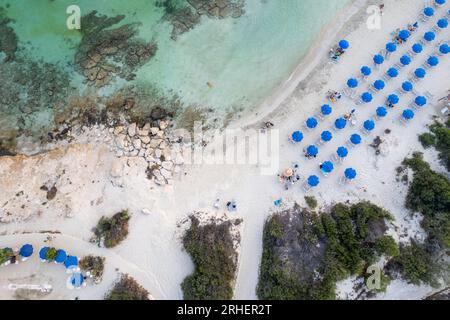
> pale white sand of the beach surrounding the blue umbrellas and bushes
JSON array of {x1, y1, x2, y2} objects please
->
[{"x1": 0, "y1": 0, "x2": 450, "y2": 299}]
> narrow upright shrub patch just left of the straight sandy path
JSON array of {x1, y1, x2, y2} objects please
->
[{"x1": 181, "y1": 217, "x2": 237, "y2": 300}]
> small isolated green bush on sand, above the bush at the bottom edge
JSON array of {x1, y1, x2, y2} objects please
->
[{"x1": 94, "y1": 210, "x2": 130, "y2": 248}]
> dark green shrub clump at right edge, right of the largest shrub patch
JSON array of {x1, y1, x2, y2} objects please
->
[{"x1": 403, "y1": 153, "x2": 450, "y2": 248}]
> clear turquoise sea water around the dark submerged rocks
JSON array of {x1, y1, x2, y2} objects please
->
[{"x1": 0, "y1": 0, "x2": 349, "y2": 138}]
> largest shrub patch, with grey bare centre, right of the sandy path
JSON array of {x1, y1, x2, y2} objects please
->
[{"x1": 257, "y1": 202, "x2": 398, "y2": 300}]
